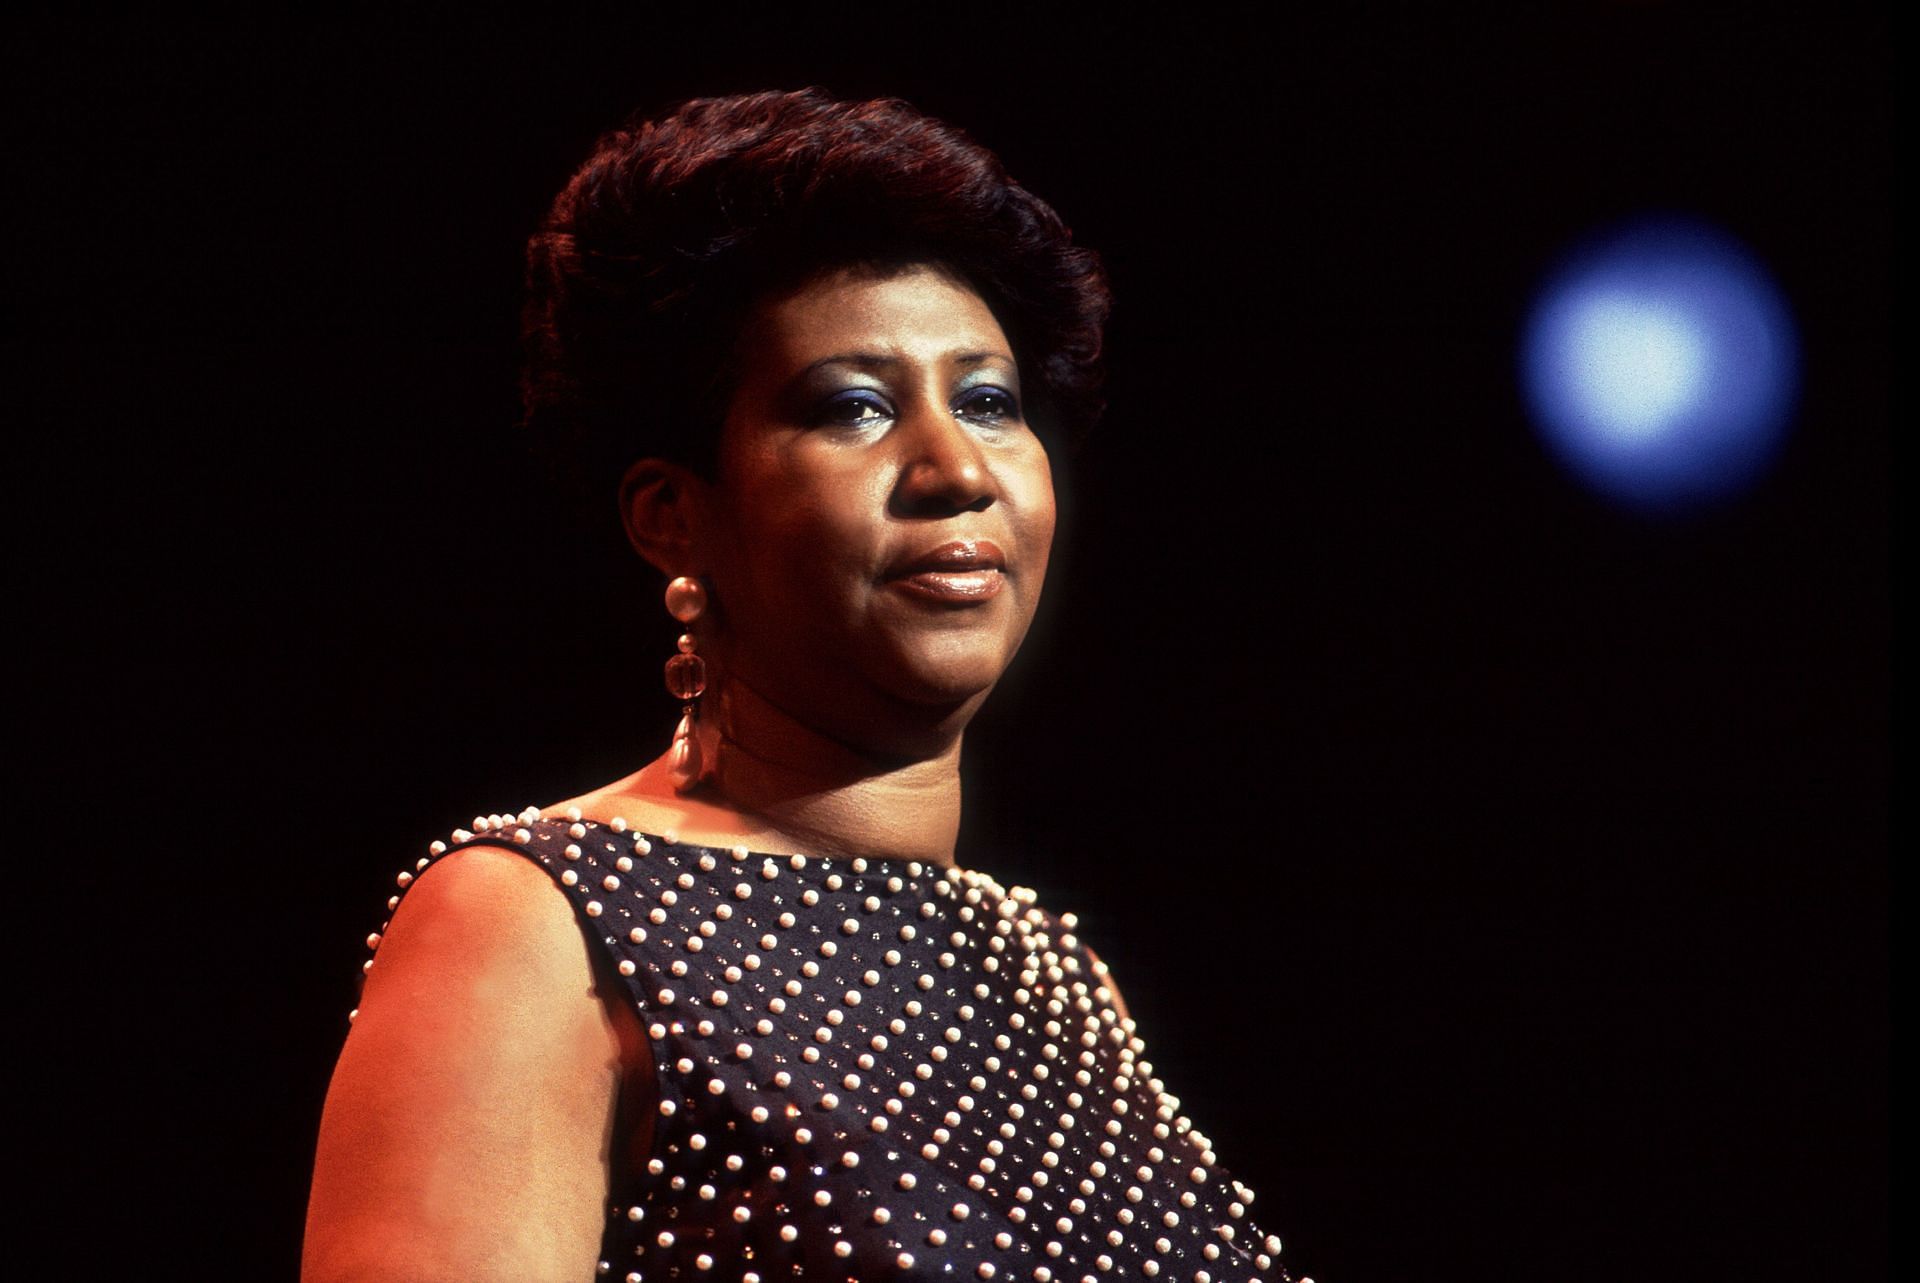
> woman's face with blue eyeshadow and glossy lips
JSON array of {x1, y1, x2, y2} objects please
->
[{"x1": 701, "y1": 267, "x2": 1054, "y2": 747}]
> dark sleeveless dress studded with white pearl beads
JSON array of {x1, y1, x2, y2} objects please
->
[{"x1": 355, "y1": 811, "x2": 1290, "y2": 1283}]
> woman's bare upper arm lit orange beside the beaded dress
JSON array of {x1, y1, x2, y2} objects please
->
[{"x1": 301, "y1": 847, "x2": 632, "y2": 1283}]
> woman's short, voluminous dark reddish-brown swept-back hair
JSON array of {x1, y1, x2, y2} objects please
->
[{"x1": 520, "y1": 88, "x2": 1108, "y2": 515}]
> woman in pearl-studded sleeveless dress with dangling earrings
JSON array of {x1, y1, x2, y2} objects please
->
[{"x1": 305, "y1": 92, "x2": 1286, "y2": 1283}]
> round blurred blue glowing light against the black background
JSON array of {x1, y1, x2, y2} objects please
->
[{"x1": 1521, "y1": 219, "x2": 1799, "y2": 509}]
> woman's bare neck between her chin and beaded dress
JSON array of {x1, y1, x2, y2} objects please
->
[{"x1": 559, "y1": 682, "x2": 960, "y2": 864}]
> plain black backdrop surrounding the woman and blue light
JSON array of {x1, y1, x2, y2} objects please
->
[{"x1": 22, "y1": 4, "x2": 1891, "y2": 1283}]
